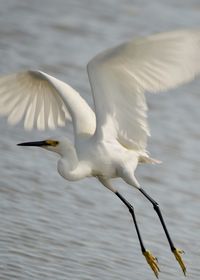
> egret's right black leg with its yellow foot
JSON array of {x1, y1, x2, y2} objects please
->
[{"x1": 139, "y1": 188, "x2": 186, "y2": 276}]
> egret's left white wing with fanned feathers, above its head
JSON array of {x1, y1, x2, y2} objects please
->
[{"x1": 0, "y1": 71, "x2": 96, "y2": 134}]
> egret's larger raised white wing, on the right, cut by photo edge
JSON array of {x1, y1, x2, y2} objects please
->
[{"x1": 88, "y1": 30, "x2": 200, "y2": 150}]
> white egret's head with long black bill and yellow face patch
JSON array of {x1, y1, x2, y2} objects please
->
[{"x1": 17, "y1": 139, "x2": 61, "y2": 154}]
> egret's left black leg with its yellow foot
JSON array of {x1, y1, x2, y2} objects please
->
[{"x1": 115, "y1": 191, "x2": 160, "y2": 278}]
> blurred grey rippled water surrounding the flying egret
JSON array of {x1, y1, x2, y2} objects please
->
[{"x1": 0, "y1": 0, "x2": 200, "y2": 280}]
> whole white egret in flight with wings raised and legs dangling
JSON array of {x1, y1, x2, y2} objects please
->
[{"x1": 0, "y1": 30, "x2": 200, "y2": 277}]
